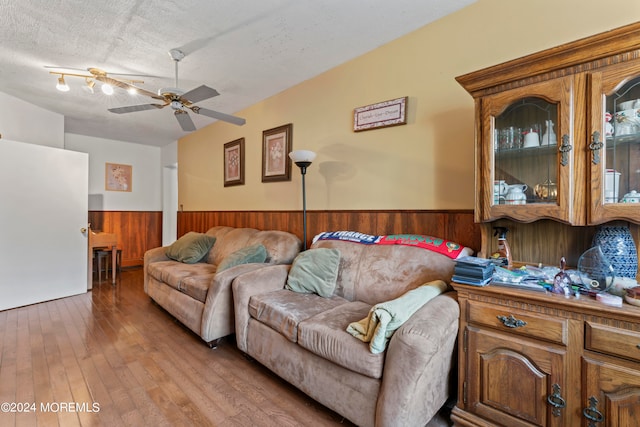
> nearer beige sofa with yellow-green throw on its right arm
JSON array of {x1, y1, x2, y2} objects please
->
[{"x1": 233, "y1": 236, "x2": 471, "y2": 427}]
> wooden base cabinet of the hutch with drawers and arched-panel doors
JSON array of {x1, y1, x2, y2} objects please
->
[{"x1": 452, "y1": 284, "x2": 640, "y2": 427}]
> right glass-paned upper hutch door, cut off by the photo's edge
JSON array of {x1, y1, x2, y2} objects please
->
[{"x1": 589, "y1": 64, "x2": 640, "y2": 224}]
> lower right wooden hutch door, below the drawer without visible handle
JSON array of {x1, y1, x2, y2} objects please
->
[{"x1": 583, "y1": 359, "x2": 640, "y2": 427}]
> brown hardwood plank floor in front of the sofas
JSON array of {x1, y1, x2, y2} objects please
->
[{"x1": 0, "y1": 268, "x2": 352, "y2": 427}]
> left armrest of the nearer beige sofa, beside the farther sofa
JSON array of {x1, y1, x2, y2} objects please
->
[{"x1": 232, "y1": 264, "x2": 291, "y2": 353}]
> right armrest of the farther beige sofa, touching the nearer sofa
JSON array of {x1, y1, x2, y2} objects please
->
[{"x1": 200, "y1": 263, "x2": 269, "y2": 342}]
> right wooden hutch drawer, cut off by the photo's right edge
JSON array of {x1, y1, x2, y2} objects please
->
[{"x1": 584, "y1": 322, "x2": 640, "y2": 362}]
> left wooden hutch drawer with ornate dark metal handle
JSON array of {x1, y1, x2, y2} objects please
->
[{"x1": 468, "y1": 301, "x2": 567, "y2": 345}]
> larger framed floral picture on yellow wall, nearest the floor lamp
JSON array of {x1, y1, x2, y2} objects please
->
[{"x1": 262, "y1": 123, "x2": 293, "y2": 182}]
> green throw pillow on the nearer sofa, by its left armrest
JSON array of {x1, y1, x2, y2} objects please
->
[{"x1": 285, "y1": 248, "x2": 340, "y2": 298}]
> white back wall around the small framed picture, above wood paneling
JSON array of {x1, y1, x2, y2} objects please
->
[{"x1": 65, "y1": 133, "x2": 162, "y2": 211}]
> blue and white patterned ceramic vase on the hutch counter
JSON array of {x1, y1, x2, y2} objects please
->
[{"x1": 591, "y1": 225, "x2": 638, "y2": 279}]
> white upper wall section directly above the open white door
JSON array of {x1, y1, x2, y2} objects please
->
[{"x1": 0, "y1": 92, "x2": 64, "y2": 148}]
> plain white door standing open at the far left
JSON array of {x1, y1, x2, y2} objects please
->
[{"x1": 0, "y1": 139, "x2": 89, "y2": 310}]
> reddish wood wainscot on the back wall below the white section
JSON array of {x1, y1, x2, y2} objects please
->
[{"x1": 89, "y1": 211, "x2": 162, "y2": 267}]
